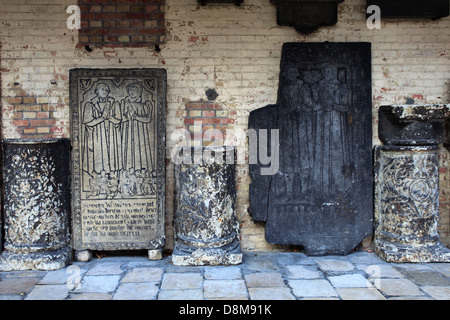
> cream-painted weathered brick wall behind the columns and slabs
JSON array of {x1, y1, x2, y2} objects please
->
[{"x1": 0, "y1": 0, "x2": 450, "y2": 250}]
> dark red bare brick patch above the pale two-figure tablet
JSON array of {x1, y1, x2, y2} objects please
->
[{"x1": 78, "y1": 0, "x2": 166, "y2": 48}]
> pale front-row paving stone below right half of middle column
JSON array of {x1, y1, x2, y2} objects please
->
[{"x1": 203, "y1": 280, "x2": 248, "y2": 300}]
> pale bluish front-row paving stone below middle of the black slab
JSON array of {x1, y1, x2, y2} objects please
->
[{"x1": 289, "y1": 279, "x2": 338, "y2": 298}]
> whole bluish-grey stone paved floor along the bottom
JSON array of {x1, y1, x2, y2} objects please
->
[{"x1": 0, "y1": 252, "x2": 450, "y2": 300}]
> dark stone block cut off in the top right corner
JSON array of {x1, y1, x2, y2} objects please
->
[{"x1": 367, "y1": 0, "x2": 449, "y2": 19}]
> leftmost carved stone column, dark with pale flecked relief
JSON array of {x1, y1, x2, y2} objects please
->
[{"x1": 0, "y1": 139, "x2": 72, "y2": 271}]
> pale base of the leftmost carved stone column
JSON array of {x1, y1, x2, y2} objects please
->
[{"x1": 0, "y1": 247, "x2": 72, "y2": 271}]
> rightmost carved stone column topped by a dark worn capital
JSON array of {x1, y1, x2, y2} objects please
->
[{"x1": 374, "y1": 105, "x2": 450, "y2": 263}]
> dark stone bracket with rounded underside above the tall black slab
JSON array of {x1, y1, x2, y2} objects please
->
[{"x1": 270, "y1": 0, "x2": 343, "y2": 34}]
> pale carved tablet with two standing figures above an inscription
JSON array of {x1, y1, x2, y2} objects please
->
[{"x1": 70, "y1": 69, "x2": 167, "y2": 250}]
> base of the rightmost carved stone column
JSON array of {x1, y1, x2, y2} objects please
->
[{"x1": 375, "y1": 240, "x2": 450, "y2": 263}]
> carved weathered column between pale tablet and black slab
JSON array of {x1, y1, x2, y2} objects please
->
[{"x1": 172, "y1": 147, "x2": 242, "y2": 265}]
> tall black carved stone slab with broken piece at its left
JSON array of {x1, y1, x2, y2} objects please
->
[{"x1": 249, "y1": 43, "x2": 373, "y2": 255}]
